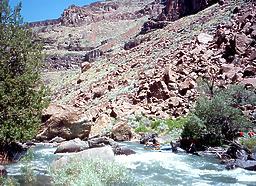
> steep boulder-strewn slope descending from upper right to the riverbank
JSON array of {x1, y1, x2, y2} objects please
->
[{"x1": 37, "y1": 1, "x2": 256, "y2": 138}]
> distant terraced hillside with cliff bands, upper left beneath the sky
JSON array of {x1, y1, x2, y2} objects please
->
[{"x1": 30, "y1": 0, "x2": 163, "y2": 71}]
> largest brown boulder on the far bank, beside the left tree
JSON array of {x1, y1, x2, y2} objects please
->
[{"x1": 36, "y1": 104, "x2": 91, "y2": 141}]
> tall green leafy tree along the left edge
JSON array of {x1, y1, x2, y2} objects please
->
[{"x1": 0, "y1": 0, "x2": 47, "y2": 144}]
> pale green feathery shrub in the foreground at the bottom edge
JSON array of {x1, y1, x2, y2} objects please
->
[{"x1": 50, "y1": 159, "x2": 139, "y2": 186}]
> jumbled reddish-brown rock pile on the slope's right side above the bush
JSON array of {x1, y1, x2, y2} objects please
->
[{"x1": 133, "y1": 1, "x2": 256, "y2": 117}]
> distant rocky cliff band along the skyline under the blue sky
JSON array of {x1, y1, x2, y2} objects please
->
[{"x1": 30, "y1": 0, "x2": 163, "y2": 27}]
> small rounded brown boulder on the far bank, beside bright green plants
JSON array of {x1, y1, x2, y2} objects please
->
[{"x1": 111, "y1": 122, "x2": 132, "y2": 141}]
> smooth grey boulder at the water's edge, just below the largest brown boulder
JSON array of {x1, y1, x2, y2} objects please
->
[{"x1": 54, "y1": 138, "x2": 89, "y2": 154}]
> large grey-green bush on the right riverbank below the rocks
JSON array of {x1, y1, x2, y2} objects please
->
[{"x1": 182, "y1": 84, "x2": 256, "y2": 145}]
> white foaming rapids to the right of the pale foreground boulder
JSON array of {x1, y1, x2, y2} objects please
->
[{"x1": 116, "y1": 144, "x2": 256, "y2": 186}]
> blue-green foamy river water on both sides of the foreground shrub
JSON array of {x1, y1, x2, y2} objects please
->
[{"x1": 7, "y1": 143, "x2": 256, "y2": 186}]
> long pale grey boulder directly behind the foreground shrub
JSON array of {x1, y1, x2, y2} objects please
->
[{"x1": 52, "y1": 146, "x2": 114, "y2": 169}]
